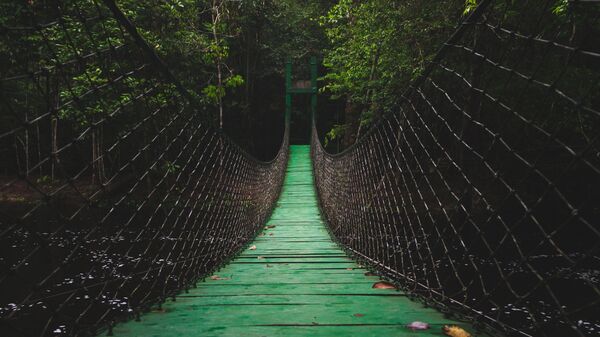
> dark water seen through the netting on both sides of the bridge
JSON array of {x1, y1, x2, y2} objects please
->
[{"x1": 0, "y1": 200, "x2": 600, "y2": 337}]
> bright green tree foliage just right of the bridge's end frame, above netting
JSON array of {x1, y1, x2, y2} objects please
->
[{"x1": 320, "y1": 0, "x2": 462, "y2": 136}]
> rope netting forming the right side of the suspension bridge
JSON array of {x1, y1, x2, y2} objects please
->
[{"x1": 312, "y1": 0, "x2": 600, "y2": 336}]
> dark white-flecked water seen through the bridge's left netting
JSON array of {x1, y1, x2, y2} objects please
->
[{"x1": 0, "y1": 198, "x2": 248, "y2": 337}]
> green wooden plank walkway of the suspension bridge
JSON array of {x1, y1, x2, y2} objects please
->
[{"x1": 114, "y1": 146, "x2": 482, "y2": 337}]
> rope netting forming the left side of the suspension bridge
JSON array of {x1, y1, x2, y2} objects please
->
[{"x1": 0, "y1": 0, "x2": 288, "y2": 336}]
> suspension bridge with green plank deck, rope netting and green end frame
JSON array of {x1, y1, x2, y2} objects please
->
[{"x1": 0, "y1": 0, "x2": 600, "y2": 337}]
